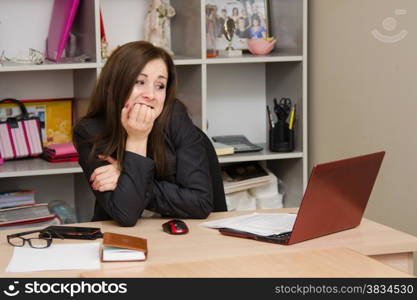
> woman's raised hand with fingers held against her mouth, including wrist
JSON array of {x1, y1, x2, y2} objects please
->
[{"x1": 121, "y1": 103, "x2": 158, "y2": 156}]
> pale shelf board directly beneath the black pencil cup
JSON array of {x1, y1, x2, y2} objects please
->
[{"x1": 218, "y1": 144, "x2": 303, "y2": 164}]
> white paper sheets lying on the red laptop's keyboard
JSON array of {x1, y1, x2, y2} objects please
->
[{"x1": 200, "y1": 213, "x2": 297, "y2": 236}]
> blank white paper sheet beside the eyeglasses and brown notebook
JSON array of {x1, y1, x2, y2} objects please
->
[{"x1": 6, "y1": 242, "x2": 100, "y2": 272}]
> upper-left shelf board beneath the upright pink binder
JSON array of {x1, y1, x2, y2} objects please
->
[{"x1": 0, "y1": 61, "x2": 97, "y2": 73}]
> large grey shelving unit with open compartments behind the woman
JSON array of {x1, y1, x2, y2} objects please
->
[{"x1": 0, "y1": 0, "x2": 308, "y2": 221}]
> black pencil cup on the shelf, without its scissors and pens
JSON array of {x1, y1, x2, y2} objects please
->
[{"x1": 269, "y1": 122, "x2": 294, "y2": 152}]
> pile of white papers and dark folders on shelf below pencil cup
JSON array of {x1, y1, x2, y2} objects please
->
[{"x1": 222, "y1": 162, "x2": 283, "y2": 211}]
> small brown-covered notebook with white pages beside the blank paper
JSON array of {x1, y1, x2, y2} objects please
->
[{"x1": 102, "y1": 232, "x2": 148, "y2": 261}]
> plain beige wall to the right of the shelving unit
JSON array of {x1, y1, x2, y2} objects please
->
[{"x1": 309, "y1": 0, "x2": 417, "y2": 274}]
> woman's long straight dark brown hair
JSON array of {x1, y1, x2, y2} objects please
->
[{"x1": 83, "y1": 41, "x2": 177, "y2": 177}]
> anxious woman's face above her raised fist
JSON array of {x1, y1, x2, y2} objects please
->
[{"x1": 126, "y1": 58, "x2": 168, "y2": 116}]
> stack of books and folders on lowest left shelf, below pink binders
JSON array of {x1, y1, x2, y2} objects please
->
[{"x1": 0, "y1": 190, "x2": 61, "y2": 230}]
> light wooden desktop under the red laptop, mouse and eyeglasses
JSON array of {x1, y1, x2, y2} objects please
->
[{"x1": 0, "y1": 209, "x2": 417, "y2": 277}]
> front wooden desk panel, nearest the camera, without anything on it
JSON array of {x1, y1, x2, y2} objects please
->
[{"x1": 81, "y1": 248, "x2": 412, "y2": 278}]
